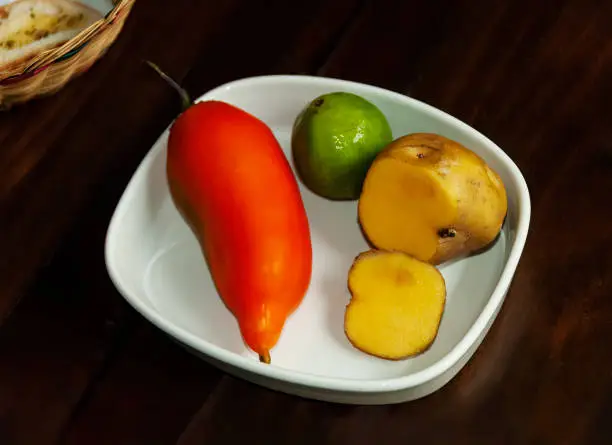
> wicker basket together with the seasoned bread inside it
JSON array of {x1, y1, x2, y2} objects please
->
[{"x1": 0, "y1": 0, "x2": 135, "y2": 109}]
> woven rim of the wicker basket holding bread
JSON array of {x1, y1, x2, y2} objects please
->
[{"x1": 0, "y1": 0, "x2": 135, "y2": 80}]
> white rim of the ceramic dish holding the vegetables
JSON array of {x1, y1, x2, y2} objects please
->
[{"x1": 105, "y1": 74, "x2": 531, "y2": 393}]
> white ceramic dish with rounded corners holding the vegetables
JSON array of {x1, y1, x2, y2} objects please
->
[{"x1": 106, "y1": 76, "x2": 530, "y2": 404}]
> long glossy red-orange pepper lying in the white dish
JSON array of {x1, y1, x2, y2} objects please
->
[{"x1": 150, "y1": 61, "x2": 312, "y2": 363}]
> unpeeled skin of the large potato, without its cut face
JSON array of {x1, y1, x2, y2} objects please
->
[{"x1": 362, "y1": 133, "x2": 507, "y2": 265}]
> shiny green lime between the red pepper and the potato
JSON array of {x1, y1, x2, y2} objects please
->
[{"x1": 291, "y1": 92, "x2": 392, "y2": 200}]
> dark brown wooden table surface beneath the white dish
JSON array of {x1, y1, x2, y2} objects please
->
[{"x1": 0, "y1": 0, "x2": 612, "y2": 445}]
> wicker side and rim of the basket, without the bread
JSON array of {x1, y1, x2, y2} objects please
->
[{"x1": 0, "y1": 0, "x2": 135, "y2": 109}]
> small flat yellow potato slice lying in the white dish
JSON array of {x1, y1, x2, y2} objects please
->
[{"x1": 344, "y1": 250, "x2": 446, "y2": 360}]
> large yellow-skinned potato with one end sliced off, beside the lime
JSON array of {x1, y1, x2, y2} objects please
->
[{"x1": 359, "y1": 133, "x2": 508, "y2": 264}]
